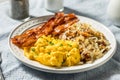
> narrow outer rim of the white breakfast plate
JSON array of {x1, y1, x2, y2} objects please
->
[{"x1": 8, "y1": 15, "x2": 117, "y2": 74}]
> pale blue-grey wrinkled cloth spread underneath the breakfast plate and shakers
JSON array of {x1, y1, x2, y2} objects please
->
[{"x1": 0, "y1": 0, "x2": 120, "y2": 80}]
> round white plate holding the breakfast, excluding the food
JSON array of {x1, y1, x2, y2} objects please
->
[{"x1": 9, "y1": 15, "x2": 116, "y2": 73}]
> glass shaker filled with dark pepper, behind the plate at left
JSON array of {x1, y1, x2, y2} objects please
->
[{"x1": 11, "y1": 0, "x2": 29, "y2": 20}]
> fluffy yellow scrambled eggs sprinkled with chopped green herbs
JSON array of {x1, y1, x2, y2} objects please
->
[{"x1": 24, "y1": 36, "x2": 80, "y2": 67}]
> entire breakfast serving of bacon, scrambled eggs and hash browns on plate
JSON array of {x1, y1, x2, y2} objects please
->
[{"x1": 11, "y1": 12, "x2": 110, "y2": 67}]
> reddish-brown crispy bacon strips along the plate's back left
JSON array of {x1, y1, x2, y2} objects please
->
[{"x1": 11, "y1": 12, "x2": 79, "y2": 48}]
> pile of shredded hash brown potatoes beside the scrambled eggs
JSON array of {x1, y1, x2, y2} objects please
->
[{"x1": 58, "y1": 22, "x2": 110, "y2": 63}]
